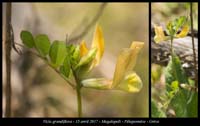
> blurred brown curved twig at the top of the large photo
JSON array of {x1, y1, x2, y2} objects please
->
[{"x1": 68, "y1": 3, "x2": 107, "y2": 43}]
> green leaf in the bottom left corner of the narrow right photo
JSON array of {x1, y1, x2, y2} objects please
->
[{"x1": 151, "y1": 100, "x2": 166, "y2": 118}]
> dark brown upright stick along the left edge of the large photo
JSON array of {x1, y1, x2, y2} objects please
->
[{"x1": 5, "y1": 3, "x2": 12, "y2": 117}]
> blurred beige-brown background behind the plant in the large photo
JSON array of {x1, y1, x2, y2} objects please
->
[{"x1": 3, "y1": 3, "x2": 149, "y2": 117}]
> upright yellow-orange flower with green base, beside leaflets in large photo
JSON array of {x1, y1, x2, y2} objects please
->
[{"x1": 77, "y1": 25, "x2": 104, "y2": 70}]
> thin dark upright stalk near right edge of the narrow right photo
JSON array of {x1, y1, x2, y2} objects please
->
[{"x1": 190, "y1": 2, "x2": 198, "y2": 87}]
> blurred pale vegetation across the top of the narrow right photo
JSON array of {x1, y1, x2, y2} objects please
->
[{"x1": 151, "y1": 2, "x2": 198, "y2": 30}]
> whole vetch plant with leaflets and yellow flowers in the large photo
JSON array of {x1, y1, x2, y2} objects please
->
[{"x1": 20, "y1": 25, "x2": 144, "y2": 117}]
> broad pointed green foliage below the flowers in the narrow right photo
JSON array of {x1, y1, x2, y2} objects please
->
[{"x1": 165, "y1": 54, "x2": 197, "y2": 117}]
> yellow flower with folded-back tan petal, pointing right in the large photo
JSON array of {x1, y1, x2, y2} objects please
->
[{"x1": 82, "y1": 42, "x2": 144, "y2": 93}]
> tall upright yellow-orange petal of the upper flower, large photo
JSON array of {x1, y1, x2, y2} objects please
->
[{"x1": 92, "y1": 25, "x2": 104, "y2": 66}]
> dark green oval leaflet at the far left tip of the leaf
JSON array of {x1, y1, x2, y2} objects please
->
[{"x1": 20, "y1": 31, "x2": 34, "y2": 48}]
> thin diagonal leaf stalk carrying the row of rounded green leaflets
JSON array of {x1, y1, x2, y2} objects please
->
[{"x1": 15, "y1": 43, "x2": 76, "y2": 89}]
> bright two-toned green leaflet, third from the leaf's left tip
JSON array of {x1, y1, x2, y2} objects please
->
[{"x1": 49, "y1": 40, "x2": 67, "y2": 67}]
